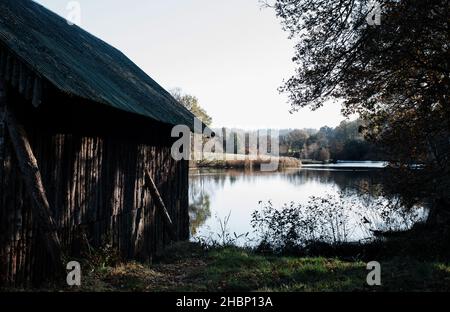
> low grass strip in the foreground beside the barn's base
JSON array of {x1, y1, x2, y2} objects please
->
[{"x1": 72, "y1": 243, "x2": 450, "y2": 292}]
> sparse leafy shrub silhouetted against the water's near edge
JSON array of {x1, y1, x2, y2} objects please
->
[{"x1": 251, "y1": 193, "x2": 426, "y2": 253}]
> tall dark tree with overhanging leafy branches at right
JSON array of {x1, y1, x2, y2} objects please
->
[{"x1": 270, "y1": 0, "x2": 450, "y2": 218}]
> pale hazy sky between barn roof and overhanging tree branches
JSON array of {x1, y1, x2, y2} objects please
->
[{"x1": 37, "y1": 0, "x2": 344, "y2": 128}]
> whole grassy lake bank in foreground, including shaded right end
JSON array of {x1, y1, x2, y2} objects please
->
[{"x1": 6, "y1": 224, "x2": 450, "y2": 292}]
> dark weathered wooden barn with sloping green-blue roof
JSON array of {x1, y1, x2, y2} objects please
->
[{"x1": 0, "y1": 0, "x2": 194, "y2": 286}]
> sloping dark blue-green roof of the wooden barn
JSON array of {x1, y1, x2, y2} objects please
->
[{"x1": 0, "y1": 0, "x2": 199, "y2": 129}]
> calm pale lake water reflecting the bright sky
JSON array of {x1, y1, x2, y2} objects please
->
[{"x1": 190, "y1": 162, "x2": 426, "y2": 244}]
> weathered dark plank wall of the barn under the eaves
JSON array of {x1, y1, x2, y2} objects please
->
[{"x1": 0, "y1": 92, "x2": 189, "y2": 286}]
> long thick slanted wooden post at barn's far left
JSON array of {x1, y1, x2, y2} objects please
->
[{"x1": 0, "y1": 80, "x2": 63, "y2": 274}]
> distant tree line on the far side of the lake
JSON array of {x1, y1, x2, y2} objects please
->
[{"x1": 172, "y1": 89, "x2": 383, "y2": 161}]
